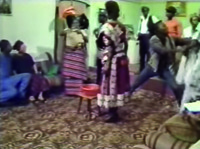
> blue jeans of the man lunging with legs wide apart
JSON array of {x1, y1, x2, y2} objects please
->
[{"x1": 130, "y1": 64, "x2": 183, "y2": 105}]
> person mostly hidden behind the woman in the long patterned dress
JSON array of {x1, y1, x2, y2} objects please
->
[{"x1": 94, "y1": 9, "x2": 107, "y2": 85}]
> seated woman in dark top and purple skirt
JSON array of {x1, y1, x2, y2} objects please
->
[{"x1": 13, "y1": 40, "x2": 49, "y2": 102}]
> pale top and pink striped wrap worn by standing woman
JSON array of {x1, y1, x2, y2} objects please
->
[{"x1": 62, "y1": 31, "x2": 87, "y2": 95}]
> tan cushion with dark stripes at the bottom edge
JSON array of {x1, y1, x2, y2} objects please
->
[{"x1": 145, "y1": 131, "x2": 192, "y2": 149}]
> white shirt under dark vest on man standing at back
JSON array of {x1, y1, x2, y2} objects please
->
[{"x1": 138, "y1": 14, "x2": 159, "y2": 34}]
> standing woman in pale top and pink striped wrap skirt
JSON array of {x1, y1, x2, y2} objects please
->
[{"x1": 61, "y1": 10, "x2": 87, "y2": 95}]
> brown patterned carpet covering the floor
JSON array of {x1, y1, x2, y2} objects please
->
[{"x1": 0, "y1": 90, "x2": 177, "y2": 149}]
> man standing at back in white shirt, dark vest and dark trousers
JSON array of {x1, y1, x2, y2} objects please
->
[{"x1": 138, "y1": 7, "x2": 159, "y2": 72}]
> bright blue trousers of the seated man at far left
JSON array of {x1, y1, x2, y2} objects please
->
[{"x1": 0, "y1": 73, "x2": 31, "y2": 102}]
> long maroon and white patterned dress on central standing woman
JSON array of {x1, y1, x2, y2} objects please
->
[{"x1": 97, "y1": 20, "x2": 130, "y2": 108}]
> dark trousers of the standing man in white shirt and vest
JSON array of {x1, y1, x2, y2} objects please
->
[{"x1": 138, "y1": 34, "x2": 150, "y2": 72}]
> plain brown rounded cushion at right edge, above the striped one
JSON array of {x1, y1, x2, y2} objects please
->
[{"x1": 163, "y1": 115, "x2": 200, "y2": 143}]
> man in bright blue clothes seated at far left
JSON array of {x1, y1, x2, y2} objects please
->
[{"x1": 0, "y1": 40, "x2": 31, "y2": 104}]
